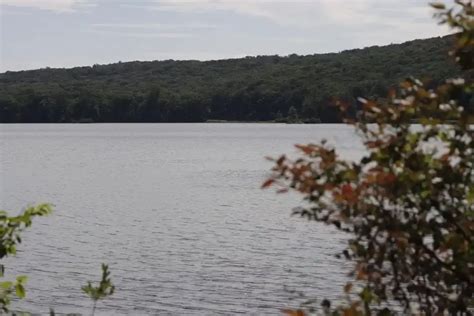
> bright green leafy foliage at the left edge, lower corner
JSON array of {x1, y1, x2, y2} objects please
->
[{"x1": 0, "y1": 204, "x2": 52, "y2": 312}]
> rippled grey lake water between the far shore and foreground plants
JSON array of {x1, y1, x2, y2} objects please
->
[{"x1": 0, "y1": 124, "x2": 362, "y2": 315}]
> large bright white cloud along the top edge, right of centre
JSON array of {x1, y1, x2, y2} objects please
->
[{"x1": 150, "y1": 0, "x2": 436, "y2": 28}]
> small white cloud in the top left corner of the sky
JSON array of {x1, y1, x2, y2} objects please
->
[{"x1": 0, "y1": 0, "x2": 94, "y2": 12}]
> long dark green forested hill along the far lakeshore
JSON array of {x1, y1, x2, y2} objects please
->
[{"x1": 0, "y1": 37, "x2": 459, "y2": 122}]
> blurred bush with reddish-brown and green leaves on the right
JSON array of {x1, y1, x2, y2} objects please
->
[{"x1": 263, "y1": 0, "x2": 474, "y2": 315}]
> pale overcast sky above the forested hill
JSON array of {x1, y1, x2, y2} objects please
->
[{"x1": 0, "y1": 0, "x2": 446, "y2": 72}]
